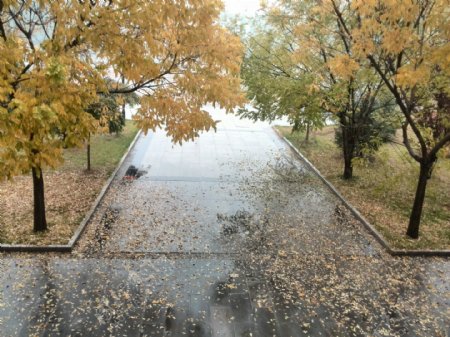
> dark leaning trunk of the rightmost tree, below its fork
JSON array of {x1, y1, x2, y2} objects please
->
[{"x1": 406, "y1": 162, "x2": 433, "y2": 239}]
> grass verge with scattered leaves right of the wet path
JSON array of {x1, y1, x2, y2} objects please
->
[{"x1": 279, "y1": 127, "x2": 450, "y2": 249}]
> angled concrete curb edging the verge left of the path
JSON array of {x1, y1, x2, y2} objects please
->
[{"x1": 0, "y1": 130, "x2": 142, "y2": 253}]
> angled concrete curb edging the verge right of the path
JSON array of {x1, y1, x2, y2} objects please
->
[{"x1": 272, "y1": 126, "x2": 450, "y2": 256}]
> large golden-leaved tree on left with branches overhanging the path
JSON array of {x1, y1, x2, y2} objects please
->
[{"x1": 0, "y1": 0, "x2": 243, "y2": 231}]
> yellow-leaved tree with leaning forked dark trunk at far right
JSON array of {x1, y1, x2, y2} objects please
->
[{"x1": 336, "y1": 0, "x2": 450, "y2": 238}]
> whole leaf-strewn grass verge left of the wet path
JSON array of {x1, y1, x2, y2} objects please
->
[{"x1": 0, "y1": 121, "x2": 138, "y2": 245}]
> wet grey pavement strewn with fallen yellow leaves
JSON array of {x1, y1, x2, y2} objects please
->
[{"x1": 0, "y1": 111, "x2": 450, "y2": 337}]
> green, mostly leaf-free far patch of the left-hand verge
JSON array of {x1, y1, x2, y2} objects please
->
[{"x1": 62, "y1": 120, "x2": 138, "y2": 174}]
